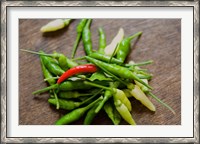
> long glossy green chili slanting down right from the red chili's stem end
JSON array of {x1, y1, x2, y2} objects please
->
[{"x1": 85, "y1": 56, "x2": 152, "y2": 89}]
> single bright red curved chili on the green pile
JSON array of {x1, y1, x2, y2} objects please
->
[{"x1": 57, "y1": 64, "x2": 97, "y2": 84}]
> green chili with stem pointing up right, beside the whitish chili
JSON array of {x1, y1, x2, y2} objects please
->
[{"x1": 117, "y1": 32, "x2": 142, "y2": 62}]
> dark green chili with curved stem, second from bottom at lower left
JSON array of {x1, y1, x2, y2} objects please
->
[{"x1": 48, "y1": 92, "x2": 99, "y2": 110}]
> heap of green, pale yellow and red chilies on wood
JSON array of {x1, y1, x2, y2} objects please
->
[{"x1": 22, "y1": 19, "x2": 175, "y2": 125}]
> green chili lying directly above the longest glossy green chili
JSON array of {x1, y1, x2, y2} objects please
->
[{"x1": 89, "y1": 52, "x2": 123, "y2": 65}]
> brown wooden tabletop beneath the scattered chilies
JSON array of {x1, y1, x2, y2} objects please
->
[{"x1": 19, "y1": 19, "x2": 181, "y2": 125}]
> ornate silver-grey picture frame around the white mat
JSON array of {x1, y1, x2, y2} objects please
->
[{"x1": 1, "y1": 1, "x2": 199, "y2": 143}]
